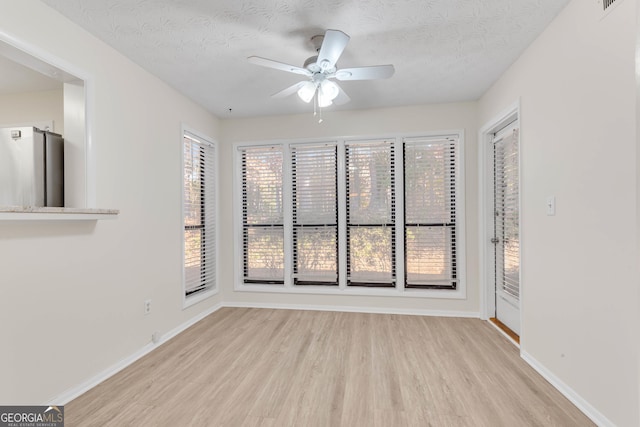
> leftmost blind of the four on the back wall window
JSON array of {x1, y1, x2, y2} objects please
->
[{"x1": 241, "y1": 146, "x2": 284, "y2": 284}]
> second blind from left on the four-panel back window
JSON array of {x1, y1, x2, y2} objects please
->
[{"x1": 291, "y1": 143, "x2": 338, "y2": 286}]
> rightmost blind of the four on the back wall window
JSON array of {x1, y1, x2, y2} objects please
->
[{"x1": 404, "y1": 138, "x2": 458, "y2": 289}]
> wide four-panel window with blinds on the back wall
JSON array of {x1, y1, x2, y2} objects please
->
[{"x1": 236, "y1": 135, "x2": 464, "y2": 298}]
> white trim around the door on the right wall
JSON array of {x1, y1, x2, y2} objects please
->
[{"x1": 478, "y1": 99, "x2": 524, "y2": 339}]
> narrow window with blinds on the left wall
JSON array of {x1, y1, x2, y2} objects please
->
[{"x1": 183, "y1": 131, "x2": 216, "y2": 299}]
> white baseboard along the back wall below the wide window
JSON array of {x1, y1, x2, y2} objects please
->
[{"x1": 222, "y1": 301, "x2": 480, "y2": 319}]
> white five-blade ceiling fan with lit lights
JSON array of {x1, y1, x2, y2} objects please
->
[{"x1": 247, "y1": 30, "x2": 395, "y2": 108}]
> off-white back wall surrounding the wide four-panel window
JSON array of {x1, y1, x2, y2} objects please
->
[{"x1": 220, "y1": 102, "x2": 479, "y2": 315}]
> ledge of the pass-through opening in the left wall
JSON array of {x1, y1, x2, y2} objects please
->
[{"x1": 0, "y1": 206, "x2": 120, "y2": 221}]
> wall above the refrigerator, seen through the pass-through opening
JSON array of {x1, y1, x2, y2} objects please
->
[{"x1": 0, "y1": 90, "x2": 64, "y2": 135}]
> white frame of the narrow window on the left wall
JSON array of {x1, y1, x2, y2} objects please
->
[{"x1": 180, "y1": 124, "x2": 220, "y2": 309}]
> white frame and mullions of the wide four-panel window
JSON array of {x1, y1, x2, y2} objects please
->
[{"x1": 233, "y1": 130, "x2": 467, "y2": 299}]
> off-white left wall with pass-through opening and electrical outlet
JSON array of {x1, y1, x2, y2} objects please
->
[{"x1": 0, "y1": 0, "x2": 220, "y2": 404}]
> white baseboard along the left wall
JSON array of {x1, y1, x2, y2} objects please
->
[{"x1": 43, "y1": 303, "x2": 223, "y2": 406}]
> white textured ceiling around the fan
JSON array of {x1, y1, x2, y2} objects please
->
[{"x1": 43, "y1": 0, "x2": 569, "y2": 118}]
